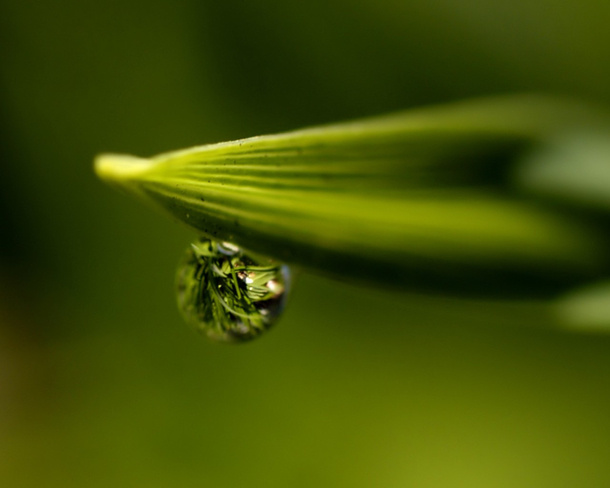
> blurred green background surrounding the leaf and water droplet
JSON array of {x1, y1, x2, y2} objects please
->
[{"x1": 0, "y1": 0, "x2": 610, "y2": 488}]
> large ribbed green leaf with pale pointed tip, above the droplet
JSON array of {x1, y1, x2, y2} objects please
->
[{"x1": 95, "y1": 96, "x2": 607, "y2": 297}]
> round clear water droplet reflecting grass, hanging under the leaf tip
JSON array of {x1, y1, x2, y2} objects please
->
[{"x1": 176, "y1": 239, "x2": 290, "y2": 342}]
